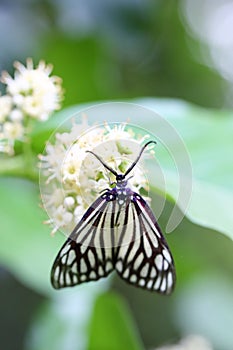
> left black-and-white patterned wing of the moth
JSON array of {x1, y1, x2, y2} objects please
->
[{"x1": 51, "y1": 196, "x2": 114, "y2": 289}]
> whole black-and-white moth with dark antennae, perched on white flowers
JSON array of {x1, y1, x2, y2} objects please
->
[{"x1": 51, "y1": 141, "x2": 176, "y2": 294}]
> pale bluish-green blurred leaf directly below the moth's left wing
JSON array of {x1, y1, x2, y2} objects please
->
[{"x1": 26, "y1": 280, "x2": 107, "y2": 350}]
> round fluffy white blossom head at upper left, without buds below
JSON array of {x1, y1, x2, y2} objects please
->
[{"x1": 1, "y1": 59, "x2": 62, "y2": 121}]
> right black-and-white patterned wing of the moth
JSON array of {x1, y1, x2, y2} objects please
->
[{"x1": 115, "y1": 193, "x2": 176, "y2": 294}]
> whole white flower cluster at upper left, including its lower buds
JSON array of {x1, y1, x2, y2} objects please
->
[{"x1": 0, "y1": 59, "x2": 63, "y2": 154}]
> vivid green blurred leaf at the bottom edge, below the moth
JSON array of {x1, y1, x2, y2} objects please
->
[{"x1": 88, "y1": 293, "x2": 143, "y2": 350}]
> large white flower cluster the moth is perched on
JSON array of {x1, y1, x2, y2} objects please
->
[{"x1": 40, "y1": 118, "x2": 148, "y2": 234}]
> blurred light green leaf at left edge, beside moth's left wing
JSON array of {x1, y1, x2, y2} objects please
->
[{"x1": 0, "y1": 178, "x2": 62, "y2": 294}]
